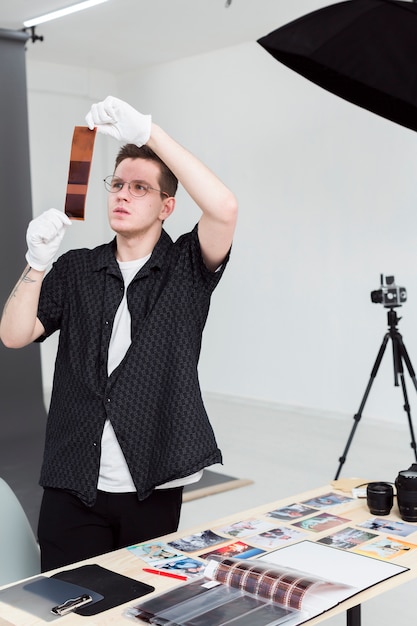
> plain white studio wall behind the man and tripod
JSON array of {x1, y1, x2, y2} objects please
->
[{"x1": 26, "y1": 42, "x2": 417, "y2": 424}]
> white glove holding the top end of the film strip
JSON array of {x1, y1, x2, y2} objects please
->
[{"x1": 85, "y1": 96, "x2": 152, "y2": 147}]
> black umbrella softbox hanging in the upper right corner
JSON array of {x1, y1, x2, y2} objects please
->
[{"x1": 258, "y1": 0, "x2": 417, "y2": 130}]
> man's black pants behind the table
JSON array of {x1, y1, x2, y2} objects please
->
[{"x1": 38, "y1": 487, "x2": 183, "y2": 572}]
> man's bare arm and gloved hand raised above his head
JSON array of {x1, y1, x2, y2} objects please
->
[{"x1": 86, "y1": 96, "x2": 237, "y2": 270}]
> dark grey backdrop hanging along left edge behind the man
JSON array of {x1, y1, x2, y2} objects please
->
[{"x1": 0, "y1": 29, "x2": 46, "y2": 524}]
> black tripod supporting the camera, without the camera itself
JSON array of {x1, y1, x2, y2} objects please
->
[{"x1": 335, "y1": 307, "x2": 417, "y2": 480}]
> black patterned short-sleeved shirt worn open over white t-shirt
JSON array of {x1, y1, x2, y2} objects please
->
[{"x1": 38, "y1": 225, "x2": 229, "y2": 505}]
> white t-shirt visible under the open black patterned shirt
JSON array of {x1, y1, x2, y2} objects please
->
[{"x1": 97, "y1": 254, "x2": 203, "y2": 493}]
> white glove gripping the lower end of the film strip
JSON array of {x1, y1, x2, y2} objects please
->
[{"x1": 26, "y1": 209, "x2": 71, "y2": 272}]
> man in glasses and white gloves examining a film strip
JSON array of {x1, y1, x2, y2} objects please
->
[{"x1": 0, "y1": 96, "x2": 237, "y2": 571}]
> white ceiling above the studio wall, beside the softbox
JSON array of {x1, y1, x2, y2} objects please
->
[{"x1": 0, "y1": 0, "x2": 329, "y2": 73}]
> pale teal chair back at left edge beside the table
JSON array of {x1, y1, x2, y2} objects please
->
[{"x1": 0, "y1": 478, "x2": 40, "y2": 585}]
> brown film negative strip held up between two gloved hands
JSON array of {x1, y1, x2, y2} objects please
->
[{"x1": 65, "y1": 126, "x2": 96, "y2": 220}]
